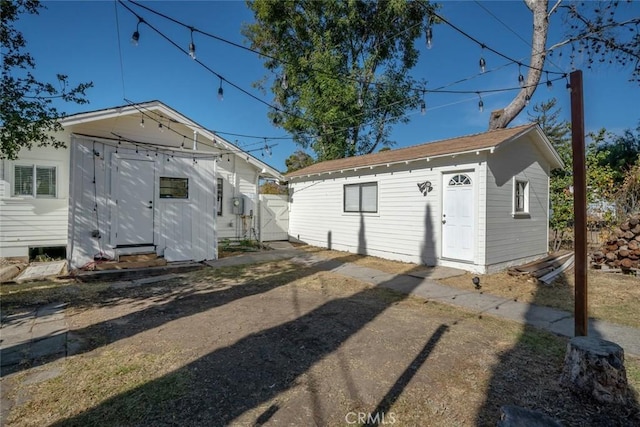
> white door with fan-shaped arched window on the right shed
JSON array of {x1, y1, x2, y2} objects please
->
[{"x1": 442, "y1": 173, "x2": 475, "y2": 261}]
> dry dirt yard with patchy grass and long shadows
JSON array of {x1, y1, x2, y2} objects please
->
[{"x1": 2, "y1": 253, "x2": 640, "y2": 426}]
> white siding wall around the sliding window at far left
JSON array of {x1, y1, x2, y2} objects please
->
[{"x1": 0, "y1": 134, "x2": 69, "y2": 257}]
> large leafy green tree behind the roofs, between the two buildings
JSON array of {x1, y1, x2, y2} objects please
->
[{"x1": 243, "y1": 0, "x2": 431, "y2": 161}]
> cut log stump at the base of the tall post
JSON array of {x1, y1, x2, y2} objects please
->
[{"x1": 560, "y1": 337, "x2": 629, "y2": 404}]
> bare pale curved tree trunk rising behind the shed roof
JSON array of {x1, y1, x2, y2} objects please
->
[{"x1": 489, "y1": 0, "x2": 549, "y2": 130}]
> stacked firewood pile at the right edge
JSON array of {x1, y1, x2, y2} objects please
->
[{"x1": 591, "y1": 216, "x2": 640, "y2": 270}]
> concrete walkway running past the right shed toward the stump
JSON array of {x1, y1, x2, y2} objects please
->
[{"x1": 206, "y1": 245, "x2": 640, "y2": 356}]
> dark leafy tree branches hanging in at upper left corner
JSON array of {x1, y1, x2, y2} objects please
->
[{"x1": 0, "y1": 0, "x2": 93, "y2": 160}]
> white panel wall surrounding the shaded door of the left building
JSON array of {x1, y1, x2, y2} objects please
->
[{"x1": 68, "y1": 138, "x2": 217, "y2": 267}]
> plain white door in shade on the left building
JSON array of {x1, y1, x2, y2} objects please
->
[{"x1": 116, "y1": 159, "x2": 155, "y2": 246}]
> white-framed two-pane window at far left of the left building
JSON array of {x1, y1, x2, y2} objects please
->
[{"x1": 13, "y1": 165, "x2": 58, "y2": 199}]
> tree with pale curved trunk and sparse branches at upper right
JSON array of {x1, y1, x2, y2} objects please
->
[{"x1": 489, "y1": 0, "x2": 640, "y2": 129}]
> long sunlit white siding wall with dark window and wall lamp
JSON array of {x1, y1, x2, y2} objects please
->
[{"x1": 289, "y1": 162, "x2": 456, "y2": 264}]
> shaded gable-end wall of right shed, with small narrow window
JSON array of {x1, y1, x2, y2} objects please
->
[{"x1": 486, "y1": 138, "x2": 549, "y2": 265}]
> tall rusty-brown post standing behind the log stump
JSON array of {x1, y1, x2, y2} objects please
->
[{"x1": 570, "y1": 70, "x2": 589, "y2": 336}]
